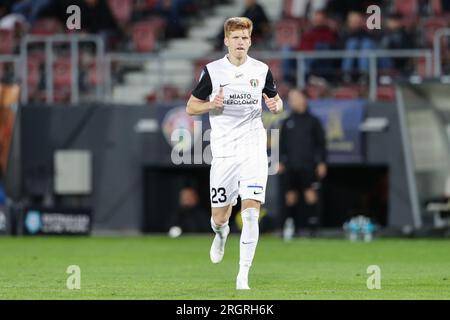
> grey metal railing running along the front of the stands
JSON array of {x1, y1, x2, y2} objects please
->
[{"x1": 5, "y1": 33, "x2": 444, "y2": 104}]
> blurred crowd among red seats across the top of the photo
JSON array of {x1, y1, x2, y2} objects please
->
[{"x1": 0, "y1": 0, "x2": 450, "y2": 101}]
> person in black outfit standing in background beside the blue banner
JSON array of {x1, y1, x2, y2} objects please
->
[{"x1": 279, "y1": 88, "x2": 327, "y2": 233}]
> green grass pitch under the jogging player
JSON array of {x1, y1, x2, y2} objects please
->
[{"x1": 0, "y1": 235, "x2": 450, "y2": 300}]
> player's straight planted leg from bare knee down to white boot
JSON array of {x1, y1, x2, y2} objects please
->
[{"x1": 236, "y1": 199, "x2": 261, "y2": 290}]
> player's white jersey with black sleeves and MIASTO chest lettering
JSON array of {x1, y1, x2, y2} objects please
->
[{"x1": 192, "y1": 56, "x2": 277, "y2": 157}]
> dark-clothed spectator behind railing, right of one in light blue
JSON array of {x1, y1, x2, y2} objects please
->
[{"x1": 379, "y1": 14, "x2": 415, "y2": 71}]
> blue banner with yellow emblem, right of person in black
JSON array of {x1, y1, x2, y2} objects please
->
[{"x1": 310, "y1": 99, "x2": 366, "y2": 163}]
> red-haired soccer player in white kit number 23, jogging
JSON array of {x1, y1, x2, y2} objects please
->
[{"x1": 186, "y1": 17, "x2": 283, "y2": 290}]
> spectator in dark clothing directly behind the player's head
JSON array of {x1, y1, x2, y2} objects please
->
[{"x1": 215, "y1": 0, "x2": 270, "y2": 51}]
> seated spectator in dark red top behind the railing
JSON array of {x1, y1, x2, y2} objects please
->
[{"x1": 282, "y1": 11, "x2": 338, "y2": 83}]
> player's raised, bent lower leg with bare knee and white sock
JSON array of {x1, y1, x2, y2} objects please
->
[{"x1": 209, "y1": 205, "x2": 232, "y2": 263}]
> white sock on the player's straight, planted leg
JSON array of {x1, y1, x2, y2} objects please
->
[{"x1": 238, "y1": 208, "x2": 259, "y2": 279}]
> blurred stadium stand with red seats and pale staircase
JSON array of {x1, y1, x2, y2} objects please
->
[{"x1": 0, "y1": 0, "x2": 450, "y2": 104}]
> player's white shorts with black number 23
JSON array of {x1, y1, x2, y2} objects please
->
[{"x1": 210, "y1": 128, "x2": 268, "y2": 208}]
